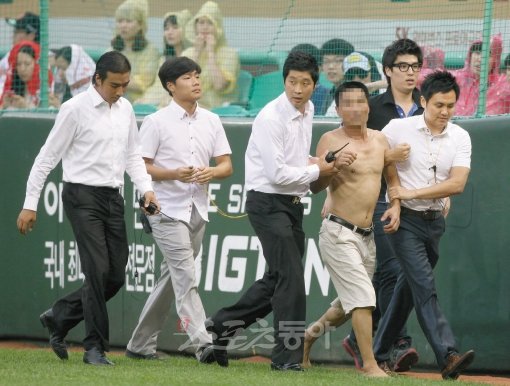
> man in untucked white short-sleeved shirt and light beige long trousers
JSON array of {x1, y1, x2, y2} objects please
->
[{"x1": 126, "y1": 56, "x2": 232, "y2": 363}]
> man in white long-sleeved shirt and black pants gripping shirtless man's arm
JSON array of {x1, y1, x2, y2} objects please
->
[{"x1": 207, "y1": 51, "x2": 348, "y2": 371}]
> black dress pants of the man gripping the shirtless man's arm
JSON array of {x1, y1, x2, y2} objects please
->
[{"x1": 212, "y1": 191, "x2": 306, "y2": 364}]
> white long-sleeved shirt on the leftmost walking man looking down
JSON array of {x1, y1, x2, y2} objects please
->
[{"x1": 23, "y1": 85, "x2": 152, "y2": 210}]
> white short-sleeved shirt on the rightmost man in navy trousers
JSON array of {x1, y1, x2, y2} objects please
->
[{"x1": 382, "y1": 115, "x2": 471, "y2": 211}]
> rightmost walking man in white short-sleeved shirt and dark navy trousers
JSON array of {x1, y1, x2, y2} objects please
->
[{"x1": 374, "y1": 69, "x2": 475, "y2": 379}]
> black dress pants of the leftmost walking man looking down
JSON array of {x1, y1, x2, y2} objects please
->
[{"x1": 53, "y1": 183, "x2": 129, "y2": 351}]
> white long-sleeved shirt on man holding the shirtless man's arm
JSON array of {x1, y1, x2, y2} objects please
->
[{"x1": 245, "y1": 93, "x2": 319, "y2": 197}]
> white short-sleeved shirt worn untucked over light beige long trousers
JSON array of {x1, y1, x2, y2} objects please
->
[{"x1": 140, "y1": 100, "x2": 232, "y2": 223}]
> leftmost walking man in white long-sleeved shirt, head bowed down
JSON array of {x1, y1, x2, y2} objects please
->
[{"x1": 17, "y1": 52, "x2": 159, "y2": 365}]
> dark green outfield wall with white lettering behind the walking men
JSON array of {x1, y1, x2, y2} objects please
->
[{"x1": 0, "y1": 113, "x2": 510, "y2": 371}]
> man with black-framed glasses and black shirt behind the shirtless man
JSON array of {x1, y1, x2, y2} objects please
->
[{"x1": 342, "y1": 39, "x2": 423, "y2": 372}]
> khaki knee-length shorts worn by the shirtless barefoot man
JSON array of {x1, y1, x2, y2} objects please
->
[{"x1": 319, "y1": 219, "x2": 375, "y2": 315}]
